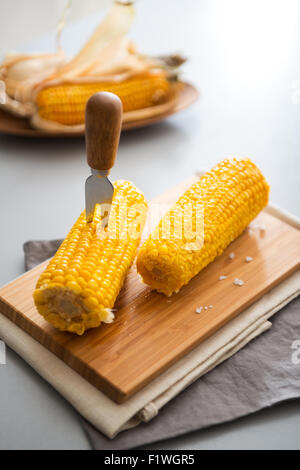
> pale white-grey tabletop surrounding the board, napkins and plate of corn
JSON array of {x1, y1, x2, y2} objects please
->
[{"x1": 0, "y1": 0, "x2": 300, "y2": 449}]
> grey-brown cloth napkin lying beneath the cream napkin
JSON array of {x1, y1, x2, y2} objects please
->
[{"x1": 24, "y1": 240, "x2": 300, "y2": 450}]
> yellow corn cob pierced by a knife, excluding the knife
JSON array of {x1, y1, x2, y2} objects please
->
[{"x1": 34, "y1": 181, "x2": 147, "y2": 335}]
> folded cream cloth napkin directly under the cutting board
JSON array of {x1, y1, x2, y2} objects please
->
[{"x1": 0, "y1": 206, "x2": 300, "y2": 438}]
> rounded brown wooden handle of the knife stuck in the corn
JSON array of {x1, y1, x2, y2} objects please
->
[{"x1": 85, "y1": 92, "x2": 123, "y2": 171}]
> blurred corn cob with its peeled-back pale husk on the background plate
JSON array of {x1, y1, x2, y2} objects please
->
[{"x1": 0, "y1": 0, "x2": 184, "y2": 133}]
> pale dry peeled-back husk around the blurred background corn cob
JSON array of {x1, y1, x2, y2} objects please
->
[{"x1": 0, "y1": 1, "x2": 184, "y2": 132}]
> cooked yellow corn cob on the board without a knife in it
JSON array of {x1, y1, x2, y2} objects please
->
[{"x1": 137, "y1": 158, "x2": 269, "y2": 296}]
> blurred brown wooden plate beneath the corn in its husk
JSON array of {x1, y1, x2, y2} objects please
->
[{"x1": 0, "y1": 83, "x2": 199, "y2": 138}]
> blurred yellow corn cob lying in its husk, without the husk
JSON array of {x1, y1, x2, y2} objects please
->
[{"x1": 36, "y1": 72, "x2": 174, "y2": 125}]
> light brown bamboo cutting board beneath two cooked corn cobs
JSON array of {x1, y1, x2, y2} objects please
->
[{"x1": 0, "y1": 178, "x2": 300, "y2": 403}]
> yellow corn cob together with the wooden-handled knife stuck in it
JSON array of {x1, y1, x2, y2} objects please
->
[{"x1": 34, "y1": 93, "x2": 147, "y2": 335}]
